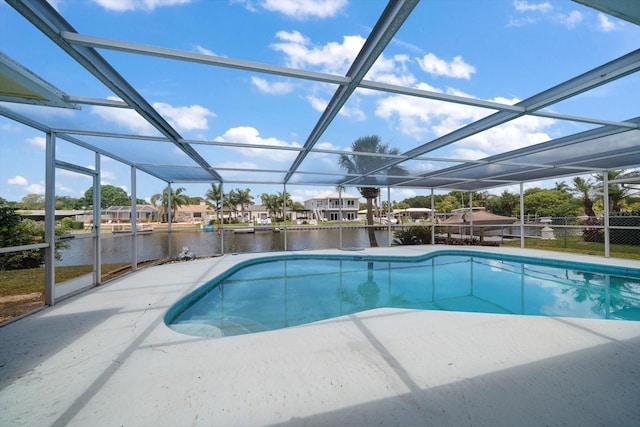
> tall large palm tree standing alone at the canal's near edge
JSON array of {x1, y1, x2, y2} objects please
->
[{"x1": 339, "y1": 135, "x2": 407, "y2": 247}]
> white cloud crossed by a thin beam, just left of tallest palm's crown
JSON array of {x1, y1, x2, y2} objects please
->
[{"x1": 215, "y1": 126, "x2": 300, "y2": 162}]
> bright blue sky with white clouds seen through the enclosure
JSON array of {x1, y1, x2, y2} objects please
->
[{"x1": 0, "y1": 0, "x2": 640, "y2": 207}]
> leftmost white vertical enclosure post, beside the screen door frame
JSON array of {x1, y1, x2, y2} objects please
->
[{"x1": 44, "y1": 132, "x2": 56, "y2": 305}]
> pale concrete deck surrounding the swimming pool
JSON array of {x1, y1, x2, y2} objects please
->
[{"x1": 0, "y1": 246, "x2": 640, "y2": 426}]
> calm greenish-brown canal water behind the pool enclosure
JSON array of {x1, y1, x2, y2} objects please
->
[{"x1": 56, "y1": 228, "x2": 389, "y2": 266}]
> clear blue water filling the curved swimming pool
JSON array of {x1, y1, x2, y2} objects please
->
[{"x1": 165, "y1": 251, "x2": 640, "y2": 337}]
